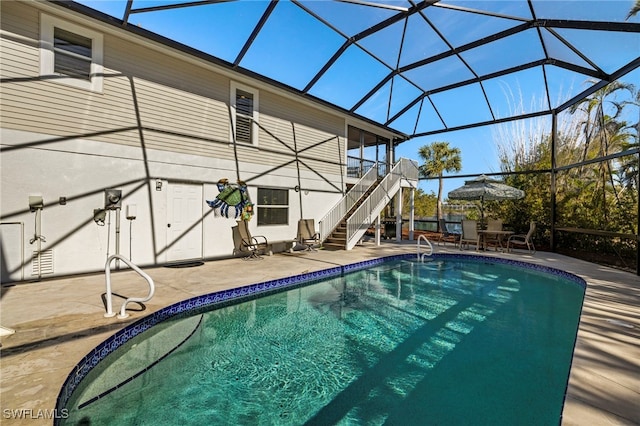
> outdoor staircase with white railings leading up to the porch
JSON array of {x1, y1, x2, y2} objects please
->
[{"x1": 319, "y1": 158, "x2": 418, "y2": 250}]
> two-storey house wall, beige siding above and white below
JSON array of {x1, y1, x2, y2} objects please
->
[{"x1": 0, "y1": 2, "x2": 396, "y2": 282}]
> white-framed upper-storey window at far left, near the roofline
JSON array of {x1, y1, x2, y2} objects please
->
[{"x1": 40, "y1": 15, "x2": 102, "y2": 92}]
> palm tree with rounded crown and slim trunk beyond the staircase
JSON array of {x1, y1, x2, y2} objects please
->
[{"x1": 418, "y1": 142, "x2": 462, "y2": 231}]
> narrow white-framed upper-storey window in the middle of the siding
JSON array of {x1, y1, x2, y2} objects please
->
[{"x1": 231, "y1": 82, "x2": 259, "y2": 146}]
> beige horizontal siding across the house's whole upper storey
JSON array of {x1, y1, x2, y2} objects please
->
[{"x1": 0, "y1": 2, "x2": 344, "y2": 176}]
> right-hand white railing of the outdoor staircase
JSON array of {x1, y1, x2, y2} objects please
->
[{"x1": 345, "y1": 158, "x2": 419, "y2": 250}]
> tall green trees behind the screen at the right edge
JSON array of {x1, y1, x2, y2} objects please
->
[{"x1": 486, "y1": 78, "x2": 640, "y2": 257}]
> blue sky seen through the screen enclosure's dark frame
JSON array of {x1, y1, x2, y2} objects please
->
[{"x1": 78, "y1": 0, "x2": 640, "y2": 196}]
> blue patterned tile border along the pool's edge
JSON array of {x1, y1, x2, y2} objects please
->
[{"x1": 54, "y1": 253, "x2": 587, "y2": 425}]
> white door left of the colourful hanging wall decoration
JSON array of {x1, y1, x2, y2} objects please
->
[{"x1": 167, "y1": 182, "x2": 203, "y2": 262}]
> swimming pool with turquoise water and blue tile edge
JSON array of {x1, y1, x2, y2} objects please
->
[{"x1": 57, "y1": 254, "x2": 585, "y2": 424}]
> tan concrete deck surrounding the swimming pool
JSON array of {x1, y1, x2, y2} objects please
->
[{"x1": 0, "y1": 241, "x2": 640, "y2": 426}]
